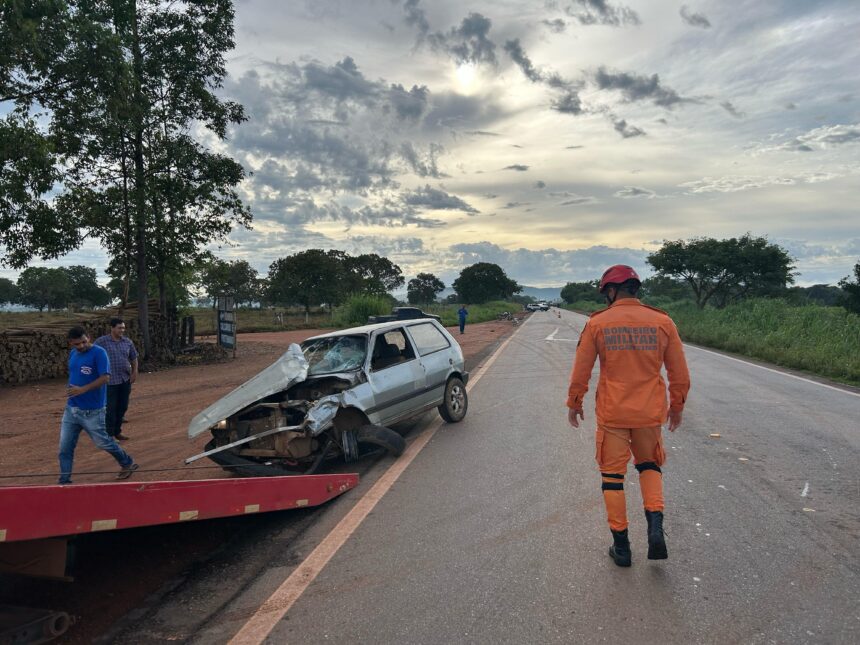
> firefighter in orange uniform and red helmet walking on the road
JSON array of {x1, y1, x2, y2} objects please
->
[{"x1": 567, "y1": 264, "x2": 690, "y2": 567}]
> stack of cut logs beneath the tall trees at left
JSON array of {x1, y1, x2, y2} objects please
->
[{"x1": 0, "y1": 300, "x2": 177, "y2": 383}]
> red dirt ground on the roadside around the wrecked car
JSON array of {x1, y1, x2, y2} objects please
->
[{"x1": 0, "y1": 322, "x2": 514, "y2": 486}]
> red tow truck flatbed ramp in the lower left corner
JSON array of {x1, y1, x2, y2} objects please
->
[{"x1": 0, "y1": 473, "x2": 358, "y2": 643}]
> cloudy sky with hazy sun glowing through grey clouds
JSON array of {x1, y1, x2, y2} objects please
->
[{"x1": 6, "y1": 0, "x2": 860, "y2": 286}]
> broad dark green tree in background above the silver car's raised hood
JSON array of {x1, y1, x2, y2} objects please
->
[{"x1": 268, "y1": 249, "x2": 345, "y2": 314}]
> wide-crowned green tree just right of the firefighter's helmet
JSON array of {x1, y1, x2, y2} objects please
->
[{"x1": 648, "y1": 234, "x2": 794, "y2": 308}]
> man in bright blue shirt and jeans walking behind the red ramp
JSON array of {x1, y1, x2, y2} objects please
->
[{"x1": 59, "y1": 327, "x2": 138, "y2": 484}]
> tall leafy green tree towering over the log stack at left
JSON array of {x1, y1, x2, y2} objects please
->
[{"x1": 0, "y1": 0, "x2": 250, "y2": 355}]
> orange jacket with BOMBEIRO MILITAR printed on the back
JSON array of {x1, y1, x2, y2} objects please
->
[{"x1": 567, "y1": 298, "x2": 690, "y2": 428}]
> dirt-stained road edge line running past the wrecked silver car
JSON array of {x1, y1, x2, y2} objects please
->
[{"x1": 229, "y1": 316, "x2": 522, "y2": 645}]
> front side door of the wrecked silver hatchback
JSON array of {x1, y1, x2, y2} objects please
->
[{"x1": 366, "y1": 327, "x2": 427, "y2": 425}]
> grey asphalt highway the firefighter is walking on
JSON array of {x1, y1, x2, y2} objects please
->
[{"x1": 116, "y1": 310, "x2": 860, "y2": 644}]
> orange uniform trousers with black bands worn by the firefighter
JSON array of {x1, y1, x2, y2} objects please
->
[{"x1": 596, "y1": 425, "x2": 666, "y2": 531}]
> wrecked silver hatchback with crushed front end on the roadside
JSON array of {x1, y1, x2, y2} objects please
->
[{"x1": 185, "y1": 319, "x2": 469, "y2": 476}]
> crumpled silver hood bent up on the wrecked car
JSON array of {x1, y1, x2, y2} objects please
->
[{"x1": 188, "y1": 343, "x2": 308, "y2": 438}]
